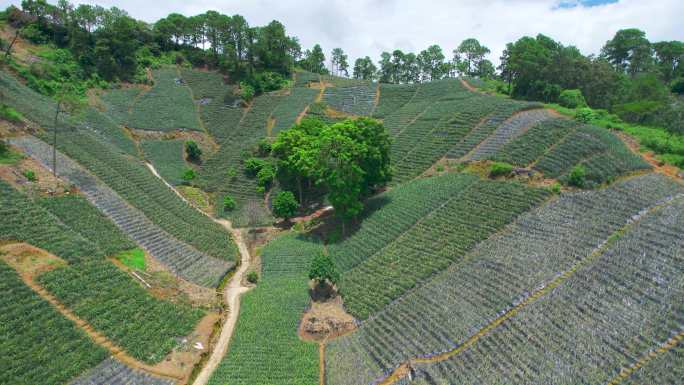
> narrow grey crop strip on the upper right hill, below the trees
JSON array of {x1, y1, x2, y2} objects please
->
[{"x1": 466, "y1": 109, "x2": 553, "y2": 160}]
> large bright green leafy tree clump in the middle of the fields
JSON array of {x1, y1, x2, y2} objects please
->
[{"x1": 272, "y1": 118, "x2": 391, "y2": 219}]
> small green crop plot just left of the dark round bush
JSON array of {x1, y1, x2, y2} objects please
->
[{"x1": 140, "y1": 140, "x2": 189, "y2": 185}]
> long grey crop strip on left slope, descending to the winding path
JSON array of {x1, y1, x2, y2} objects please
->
[{"x1": 14, "y1": 138, "x2": 232, "y2": 286}]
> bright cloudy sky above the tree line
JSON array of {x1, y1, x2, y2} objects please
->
[{"x1": 0, "y1": 0, "x2": 684, "y2": 64}]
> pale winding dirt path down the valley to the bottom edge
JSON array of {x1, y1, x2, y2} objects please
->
[{"x1": 146, "y1": 163, "x2": 250, "y2": 385}]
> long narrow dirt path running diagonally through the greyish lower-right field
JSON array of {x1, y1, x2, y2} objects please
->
[{"x1": 379, "y1": 194, "x2": 684, "y2": 385}]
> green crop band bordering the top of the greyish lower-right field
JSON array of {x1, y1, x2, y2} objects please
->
[{"x1": 339, "y1": 174, "x2": 547, "y2": 319}]
